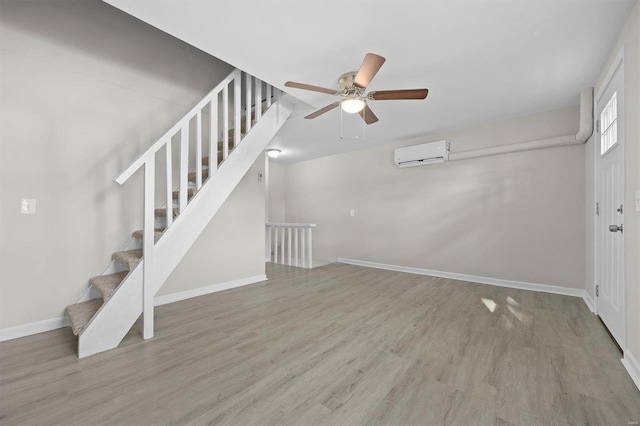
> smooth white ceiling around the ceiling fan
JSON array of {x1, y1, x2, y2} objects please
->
[{"x1": 105, "y1": 0, "x2": 636, "y2": 163}]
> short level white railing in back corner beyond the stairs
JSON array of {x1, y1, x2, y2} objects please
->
[{"x1": 265, "y1": 223, "x2": 316, "y2": 268}]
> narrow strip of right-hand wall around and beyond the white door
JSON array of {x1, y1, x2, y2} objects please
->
[{"x1": 587, "y1": 2, "x2": 640, "y2": 360}]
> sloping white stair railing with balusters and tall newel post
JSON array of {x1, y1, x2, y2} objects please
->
[{"x1": 115, "y1": 69, "x2": 282, "y2": 339}]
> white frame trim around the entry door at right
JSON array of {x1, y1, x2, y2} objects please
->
[{"x1": 593, "y1": 45, "x2": 628, "y2": 352}]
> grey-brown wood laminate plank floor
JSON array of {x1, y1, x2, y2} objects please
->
[{"x1": 0, "y1": 264, "x2": 640, "y2": 425}]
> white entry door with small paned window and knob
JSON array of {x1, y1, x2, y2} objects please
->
[{"x1": 596, "y1": 62, "x2": 626, "y2": 348}]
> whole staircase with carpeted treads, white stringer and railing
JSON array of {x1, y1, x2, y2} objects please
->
[{"x1": 66, "y1": 70, "x2": 292, "y2": 358}]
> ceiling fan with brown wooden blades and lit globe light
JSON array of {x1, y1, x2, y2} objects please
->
[{"x1": 284, "y1": 53, "x2": 429, "y2": 124}]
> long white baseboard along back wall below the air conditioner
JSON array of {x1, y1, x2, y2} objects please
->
[{"x1": 337, "y1": 257, "x2": 584, "y2": 298}]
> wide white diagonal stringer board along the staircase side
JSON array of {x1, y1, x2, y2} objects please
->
[{"x1": 78, "y1": 99, "x2": 293, "y2": 358}]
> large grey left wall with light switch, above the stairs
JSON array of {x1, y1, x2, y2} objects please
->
[{"x1": 0, "y1": 0, "x2": 240, "y2": 328}]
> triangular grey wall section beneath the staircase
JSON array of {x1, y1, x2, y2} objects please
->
[{"x1": 158, "y1": 160, "x2": 265, "y2": 296}]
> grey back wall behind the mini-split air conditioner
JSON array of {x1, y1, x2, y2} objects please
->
[{"x1": 286, "y1": 108, "x2": 585, "y2": 288}]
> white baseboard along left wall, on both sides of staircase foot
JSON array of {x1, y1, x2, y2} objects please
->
[{"x1": 0, "y1": 274, "x2": 267, "y2": 342}]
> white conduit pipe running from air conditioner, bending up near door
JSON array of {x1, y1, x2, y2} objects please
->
[{"x1": 449, "y1": 88, "x2": 593, "y2": 161}]
